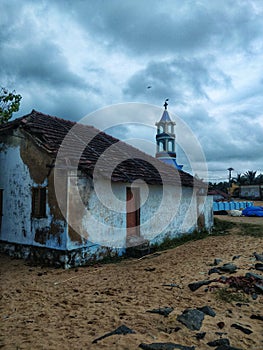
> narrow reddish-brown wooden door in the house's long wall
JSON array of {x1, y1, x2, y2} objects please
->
[{"x1": 126, "y1": 187, "x2": 140, "y2": 238}]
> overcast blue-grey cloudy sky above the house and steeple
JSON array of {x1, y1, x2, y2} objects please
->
[{"x1": 0, "y1": 0, "x2": 263, "y2": 182}]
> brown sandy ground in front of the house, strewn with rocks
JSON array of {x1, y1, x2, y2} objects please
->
[{"x1": 0, "y1": 216, "x2": 263, "y2": 350}]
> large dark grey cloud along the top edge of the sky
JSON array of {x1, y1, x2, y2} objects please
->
[{"x1": 57, "y1": 0, "x2": 262, "y2": 55}]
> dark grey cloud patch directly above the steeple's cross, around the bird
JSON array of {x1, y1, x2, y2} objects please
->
[{"x1": 124, "y1": 57, "x2": 231, "y2": 103}]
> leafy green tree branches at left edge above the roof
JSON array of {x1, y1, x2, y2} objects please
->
[{"x1": 0, "y1": 87, "x2": 22, "y2": 124}]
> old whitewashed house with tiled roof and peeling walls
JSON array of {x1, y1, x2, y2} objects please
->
[{"x1": 0, "y1": 110, "x2": 213, "y2": 267}]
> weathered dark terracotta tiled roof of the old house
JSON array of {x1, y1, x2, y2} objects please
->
[{"x1": 0, "y1": 110, "x2": 203, "y2": 187}]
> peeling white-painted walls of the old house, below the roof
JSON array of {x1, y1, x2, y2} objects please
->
[{"x1": 0, "y1": 131, "x2": 213, "y2": 267}]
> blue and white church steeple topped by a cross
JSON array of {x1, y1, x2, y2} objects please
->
[{"x1": 155, "y1": 99, "x2": 183, "y2": 169}]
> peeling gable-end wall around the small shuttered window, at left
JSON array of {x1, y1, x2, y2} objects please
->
[{"x1": 0, "y1": 133, "x2": 66, "y2": 249}]
